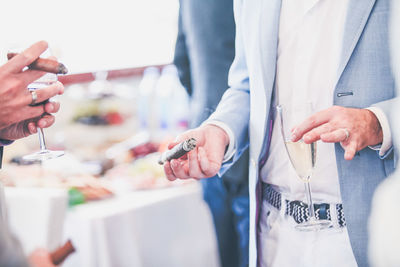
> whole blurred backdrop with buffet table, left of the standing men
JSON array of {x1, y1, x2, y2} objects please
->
[{"x1": 0, "y1": 0, "x2": 219, "y2": 267}]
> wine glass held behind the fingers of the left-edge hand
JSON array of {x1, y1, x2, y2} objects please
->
[{"x1": 22, "y1": 49, "x2": 64, "y2": 161}]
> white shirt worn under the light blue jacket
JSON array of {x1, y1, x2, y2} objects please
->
[{"x1": 261, "y1": 0, "x2": 348, "y2": 203}]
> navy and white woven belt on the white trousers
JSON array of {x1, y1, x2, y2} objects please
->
[{"x1": 263, "y1": 183, "x2": 346, "y2": 227}]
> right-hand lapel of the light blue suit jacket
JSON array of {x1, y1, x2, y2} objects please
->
[{"x1": 336, "y1": 0, "x2": 376, "y2": 86}]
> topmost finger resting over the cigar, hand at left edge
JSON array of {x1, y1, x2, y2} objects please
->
[{"x1": 4, "y1": 41, "x2": 48, "y2": 73}]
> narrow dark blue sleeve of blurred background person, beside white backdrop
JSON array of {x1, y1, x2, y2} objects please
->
[{"x1": 174, "y1": 4, "x2": 192, "y2": 96}]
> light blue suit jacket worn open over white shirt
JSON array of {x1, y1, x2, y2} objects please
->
[{"x1": 210, "y1": 0, "x2": 395, "y2": 266}]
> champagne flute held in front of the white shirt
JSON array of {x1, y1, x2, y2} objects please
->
[{"x1": 276, "y1": 103, "x2": 332, "y2": 231}]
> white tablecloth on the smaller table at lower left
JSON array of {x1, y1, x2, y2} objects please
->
[{"x1": 4, "y1": 187, "x2": 68, "y2": 255}]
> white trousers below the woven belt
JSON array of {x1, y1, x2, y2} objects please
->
[{"x1": 257, "y1": 200, "x2": 357, "y2": 267}]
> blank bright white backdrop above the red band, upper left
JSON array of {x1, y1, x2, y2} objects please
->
[{"x1": 0, "y1": 0, "x2": 179, "y2": 73}]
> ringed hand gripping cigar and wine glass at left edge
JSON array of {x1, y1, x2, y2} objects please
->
[{"x1": 0, "y1": 41, "x2": 64, "y2": 140}]
